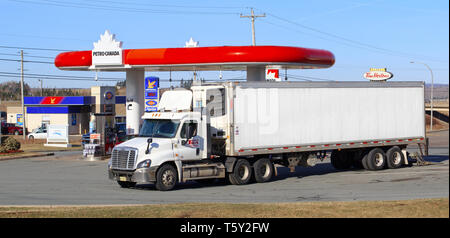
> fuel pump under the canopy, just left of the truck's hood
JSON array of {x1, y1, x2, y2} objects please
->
[{"x1": 83, "y1": 112, "x2": 116, "y2": 160}]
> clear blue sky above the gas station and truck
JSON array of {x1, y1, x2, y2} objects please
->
[{"x1": 0, "y1": 0, "x2": 449, "y2": 88}]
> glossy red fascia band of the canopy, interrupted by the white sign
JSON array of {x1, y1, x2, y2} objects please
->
[{"x1": 55, "y1": 46, "x2": 335, "y2": 70}]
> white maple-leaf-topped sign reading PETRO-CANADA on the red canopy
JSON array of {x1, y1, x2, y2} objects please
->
[{"x1": 92, "y1": 30, "x2": 122, "y2": 65}]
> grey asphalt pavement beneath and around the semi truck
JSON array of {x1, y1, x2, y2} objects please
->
[{"x1": 0, "y1": 131, "x2": 449, "y2": 206}]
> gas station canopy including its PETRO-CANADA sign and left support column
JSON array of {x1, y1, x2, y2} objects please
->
[{"x1": 55, "y1": 30, "x2": 334, "y2": 134}]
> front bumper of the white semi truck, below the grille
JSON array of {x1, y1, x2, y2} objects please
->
[{"x1": 108, "y1": 167, "x2": 158, "y2": 183}]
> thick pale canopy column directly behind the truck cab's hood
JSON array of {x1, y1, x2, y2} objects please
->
[{"x1": 126, "y1": 70, "x2": 145, "y2": 135}]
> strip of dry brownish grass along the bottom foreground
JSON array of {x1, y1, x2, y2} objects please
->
[{"x1": 0, "y1": 198, "x2": 449, "y2": 218}]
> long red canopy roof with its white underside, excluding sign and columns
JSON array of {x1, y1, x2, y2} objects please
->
[{"x1": 55, "y1": 46, "x2": 334, "y2": 71}]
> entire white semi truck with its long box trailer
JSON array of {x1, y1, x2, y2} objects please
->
[{"x1": 108, "y1": 82, "x2": 425, "y2": 190}]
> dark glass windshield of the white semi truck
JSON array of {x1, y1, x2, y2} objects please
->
[{"x1": 139, "y1": 119, "x2": 180, "y2": 138}]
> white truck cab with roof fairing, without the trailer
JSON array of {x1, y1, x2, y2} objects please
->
[{"x1": 108, "y1": 86, "x2": 224, "y2": 190}]
